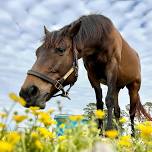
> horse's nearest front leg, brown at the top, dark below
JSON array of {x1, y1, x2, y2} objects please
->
[{"x1": 105, "y1": 59, "x2": 117, "y2": 130}]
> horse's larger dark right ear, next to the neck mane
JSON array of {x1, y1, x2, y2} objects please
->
[{"x1": 68, "y1": 20, "x2": 81, "y2": 37}]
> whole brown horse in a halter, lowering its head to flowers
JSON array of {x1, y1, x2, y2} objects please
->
[{"x1": 20, "y1": 15, "x2": 152, "y2": 135}]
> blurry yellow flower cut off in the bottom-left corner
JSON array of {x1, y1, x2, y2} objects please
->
[{"x1": 0, "y1": 141, "x2": 13, "y2": 152}]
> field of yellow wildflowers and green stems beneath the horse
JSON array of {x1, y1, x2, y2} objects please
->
[{"x1": 0, "y1": 93, "x2": 152, "y2": 152}]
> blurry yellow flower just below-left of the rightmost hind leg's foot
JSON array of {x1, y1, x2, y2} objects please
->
[{"x1": 118, "y1": 136, "x2": 132, "y2": 147}]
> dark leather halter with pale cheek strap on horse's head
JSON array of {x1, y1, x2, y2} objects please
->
[{"x1": 27, "y1": 48, "x2": 78, "y2": 99}]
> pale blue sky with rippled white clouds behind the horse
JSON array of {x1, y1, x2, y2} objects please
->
[{"x1": 0, "y1": 0, "x2": 152, "y2": 114}]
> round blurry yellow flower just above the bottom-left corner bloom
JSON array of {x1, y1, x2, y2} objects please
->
[{"x1": 6, "y1": 131, "x2": 21, "y2": 145}]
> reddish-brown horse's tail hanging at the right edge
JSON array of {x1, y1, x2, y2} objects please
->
[{"x1": 136, "y1": 99, "x2": 152, "y2": 121}]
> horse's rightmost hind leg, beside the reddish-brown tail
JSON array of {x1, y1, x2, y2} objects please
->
[{"x1": 127, "y1": 81, "x2": 140, "y2": 136}]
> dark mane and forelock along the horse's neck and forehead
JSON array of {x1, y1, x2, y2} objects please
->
[{"x1": 44, "y1": 15, "x2": 112, "y2": 46}]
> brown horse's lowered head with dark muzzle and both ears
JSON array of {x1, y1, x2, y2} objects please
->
[{"x1": 19, "y1": 21, "x2": 81, "y2": 108}]
